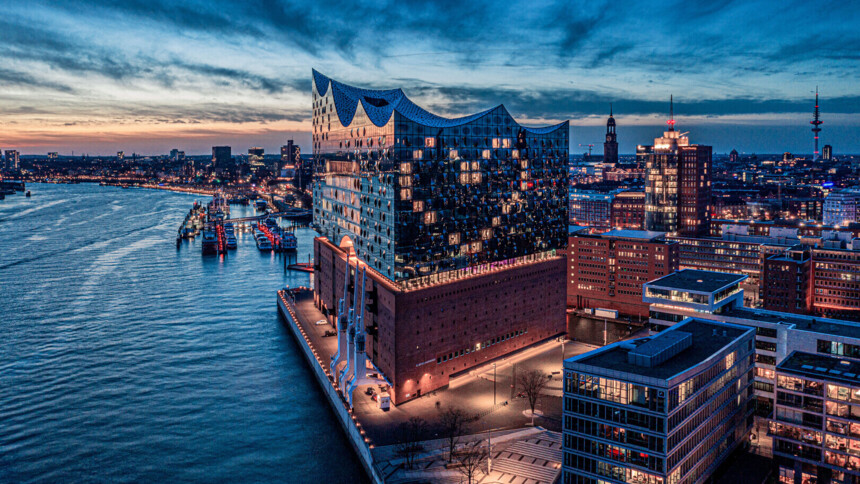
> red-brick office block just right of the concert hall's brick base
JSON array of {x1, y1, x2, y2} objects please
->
[{"x1": 567, "y1": 230, "x2": 679, "y2": 319}]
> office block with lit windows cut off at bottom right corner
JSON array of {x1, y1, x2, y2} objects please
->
[{"x1": 769, "y1": 352, "x2": 860, "y2": 484}]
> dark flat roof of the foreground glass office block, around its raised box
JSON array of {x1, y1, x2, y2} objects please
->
[{"x1": 573, "y1": 319, "x2": 754, "y2": 380}]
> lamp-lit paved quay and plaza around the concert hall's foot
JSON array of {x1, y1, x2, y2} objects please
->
[{"x1": 277, "y1": 288, "x2": 594, "y2": 482}]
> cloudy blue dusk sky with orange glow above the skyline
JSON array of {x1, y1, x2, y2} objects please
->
[{"x1": 0, "y1": 0, "x2": 860, "y2": 154}]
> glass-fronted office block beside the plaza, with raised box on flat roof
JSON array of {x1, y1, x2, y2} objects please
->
[{"x1": 562, "y1": 319, "x2": 755, "y2": 484}]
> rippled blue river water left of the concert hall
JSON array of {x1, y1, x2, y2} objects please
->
[{"x1": 0, "y1": 184, "x2": 365, "y2": 483}]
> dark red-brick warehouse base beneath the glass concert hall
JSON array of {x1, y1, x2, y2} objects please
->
[{"x1": 314, "y1": 237, "x2": 566, "y2": 405}]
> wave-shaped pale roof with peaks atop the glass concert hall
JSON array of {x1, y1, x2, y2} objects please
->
[{"x1": 313, "y1": 69, "x2": 567, "y2": 134}]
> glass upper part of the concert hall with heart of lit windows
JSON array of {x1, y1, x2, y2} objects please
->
[{"x1": 313, "y1": 72, "x2": 569, "y2": 282}]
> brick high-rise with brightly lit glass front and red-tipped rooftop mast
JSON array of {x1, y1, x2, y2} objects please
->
[{"x1": 645, "y1": 96, "x2": 711, "y2": 235}]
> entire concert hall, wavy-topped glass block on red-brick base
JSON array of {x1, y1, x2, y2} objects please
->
[{"x1": 313, "y1": 71, "x2": 569, "y2": 404}]
